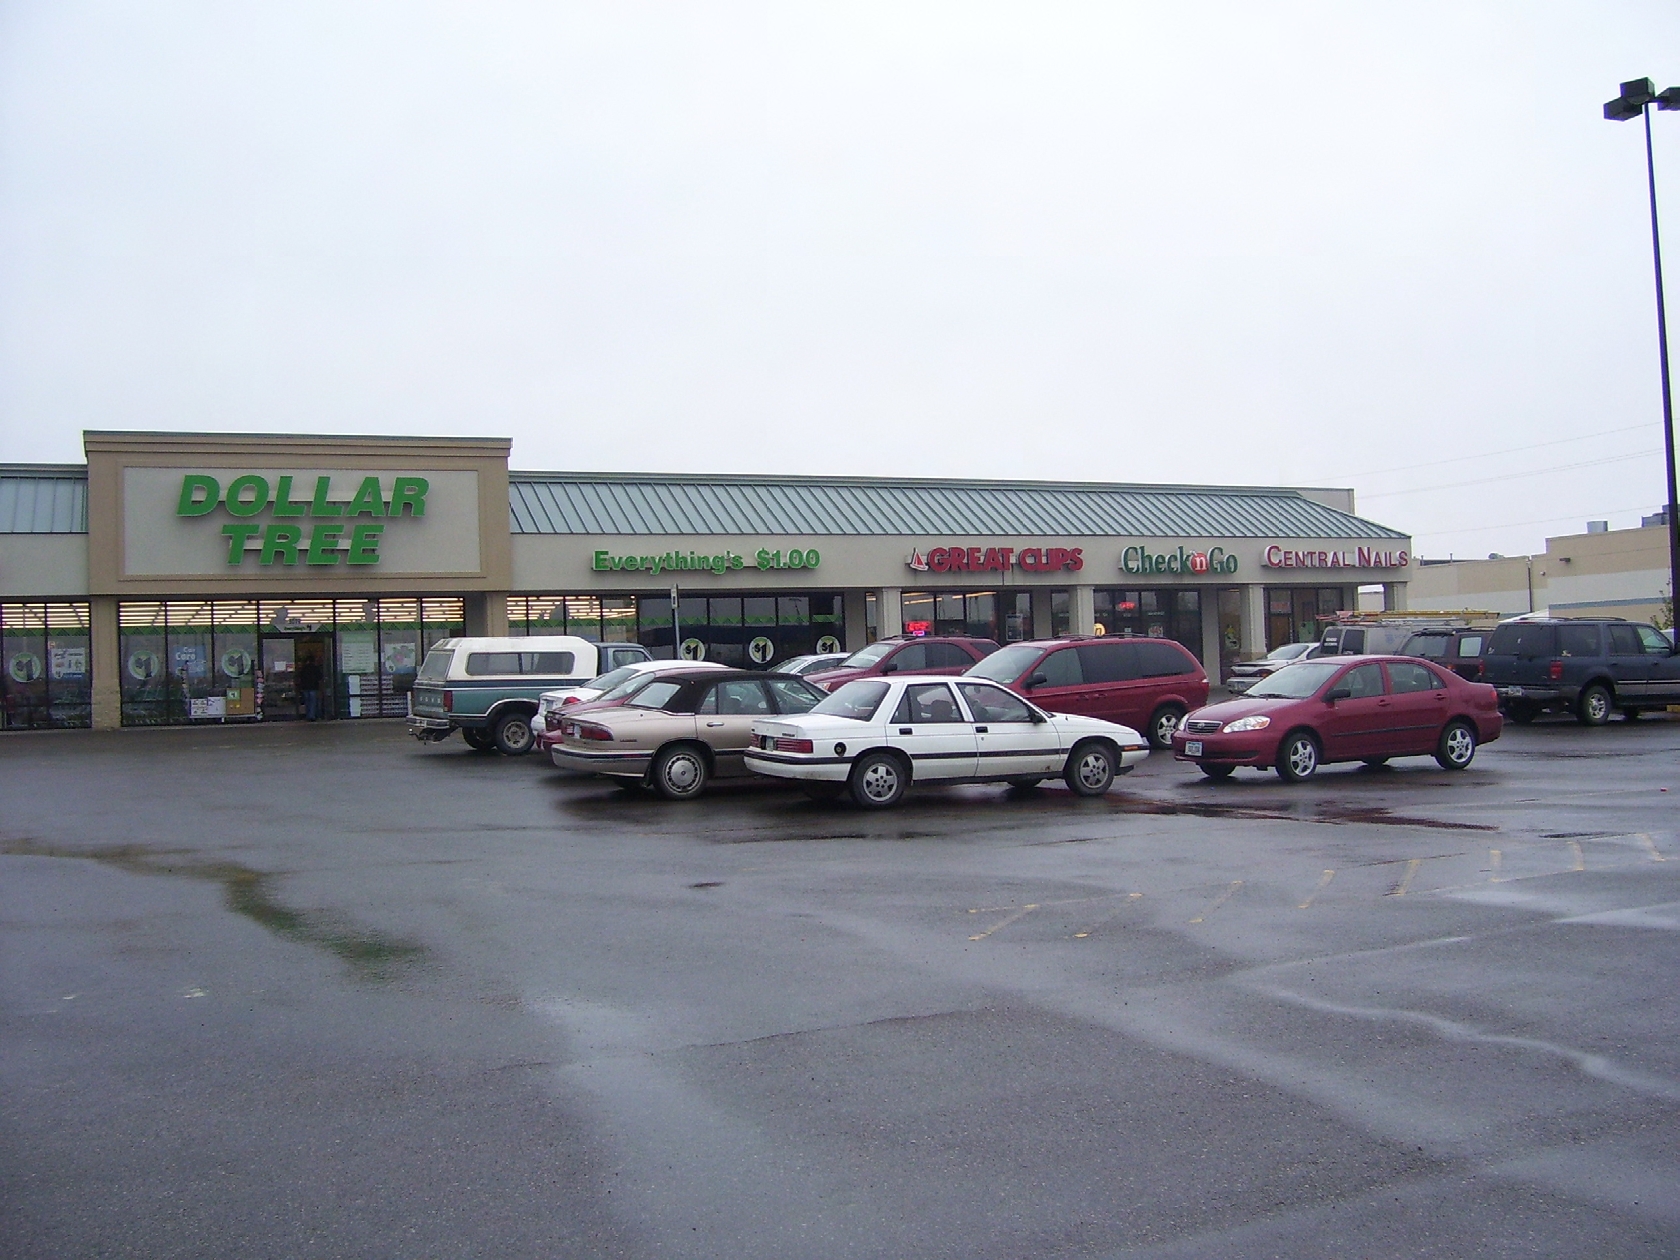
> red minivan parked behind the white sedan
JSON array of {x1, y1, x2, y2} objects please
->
[{"x1": 968, "y1": 635, "x2": 1208, "y2": 748}]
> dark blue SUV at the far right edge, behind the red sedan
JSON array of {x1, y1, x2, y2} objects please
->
[{"x1": 1482, "y1": 618, "x2": 1680, "y2": 726}]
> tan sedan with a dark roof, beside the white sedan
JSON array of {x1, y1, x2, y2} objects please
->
[{"x1": 549, "y1": 669, "x2": 827, "y2": 801}]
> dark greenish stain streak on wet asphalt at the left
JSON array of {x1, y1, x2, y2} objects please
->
[{"x1": 0, "y1": 840, "x2": 427, "y2": 981}]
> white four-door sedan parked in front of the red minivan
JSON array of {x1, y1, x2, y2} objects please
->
[{"x1": 746, "y1": 675, "x2": 1149, "y2": 808}]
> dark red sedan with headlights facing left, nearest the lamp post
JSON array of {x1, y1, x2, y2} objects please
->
[{"x1": 1173, "y1": 657, "x2": 1504, "y2": 783}]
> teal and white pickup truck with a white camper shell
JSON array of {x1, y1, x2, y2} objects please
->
[{"x1": 408, "y1": 635, "x2": 648, "y2": 756}]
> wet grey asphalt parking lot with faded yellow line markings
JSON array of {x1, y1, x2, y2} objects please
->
[{"x1": 0, "y1": 721, "x2": 1680, "y2": 1258}]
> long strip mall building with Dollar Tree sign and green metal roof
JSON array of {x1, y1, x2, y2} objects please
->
[{"x1": 0, "y1": 432, "x2": 1413, "y2": 729}]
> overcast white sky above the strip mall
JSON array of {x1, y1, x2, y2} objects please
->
[{"x1": 0, "y1": 0, "x2": 1680, "y2": 556}]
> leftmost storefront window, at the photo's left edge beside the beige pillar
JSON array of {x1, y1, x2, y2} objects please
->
[{"x1": 0, "y1": 603, "x2": 92, "y2": 729}]
